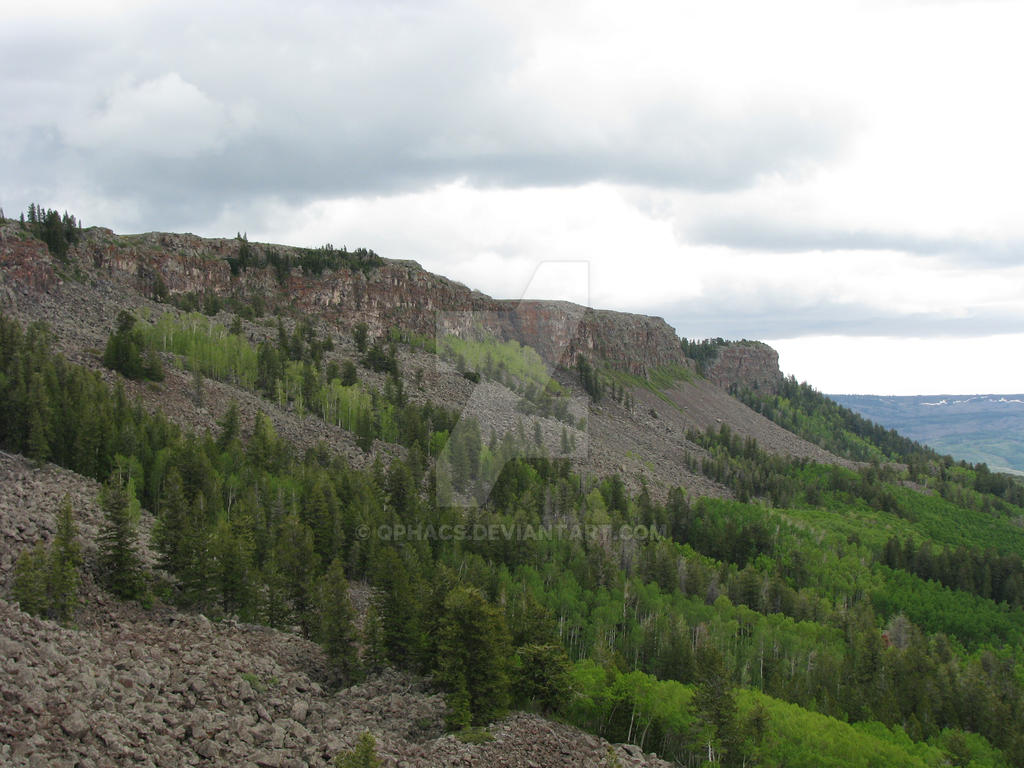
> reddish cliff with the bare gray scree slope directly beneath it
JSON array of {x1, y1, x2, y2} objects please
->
[{"x1": 0, "y1": 224, "x2": 845, "y2": 499}]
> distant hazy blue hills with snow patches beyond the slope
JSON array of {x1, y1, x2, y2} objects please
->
[{"x1": 828, "y1": 394, "x2": 1024, "y2": 474}]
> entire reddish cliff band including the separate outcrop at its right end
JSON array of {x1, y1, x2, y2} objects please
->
[{"x1": 0, "y1": 222, "x2": 781, "y2": 391}]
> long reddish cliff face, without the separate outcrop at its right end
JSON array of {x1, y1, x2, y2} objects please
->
[{"x1": 14, "y1": 226, "x2": 686, "y2": 375}]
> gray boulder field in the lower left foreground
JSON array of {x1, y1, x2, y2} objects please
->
[{"x1": 0, "y1": 455, "x2": 668, "y2": 768}]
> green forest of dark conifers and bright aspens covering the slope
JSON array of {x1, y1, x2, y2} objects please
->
[{"x1": 0, "y1": 315, "x2": 1024, "y2": 766}]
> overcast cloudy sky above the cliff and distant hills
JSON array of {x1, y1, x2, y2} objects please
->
[{"x1": 0, "y1": 0, "x2": 1024, "y2": 394}]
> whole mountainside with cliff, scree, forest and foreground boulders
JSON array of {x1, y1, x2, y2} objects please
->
[{"x1": 6, "y1": 217, "x2": 1024, "y2": 766}]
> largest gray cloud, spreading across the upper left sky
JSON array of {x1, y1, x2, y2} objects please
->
[{"x1": 0, "y1": 2, "x2": 847, "y2": 228}]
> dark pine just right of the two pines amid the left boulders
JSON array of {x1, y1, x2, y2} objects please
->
[{"x1": 99, "y1": 481, "x2": 145, "y2": 600}]
